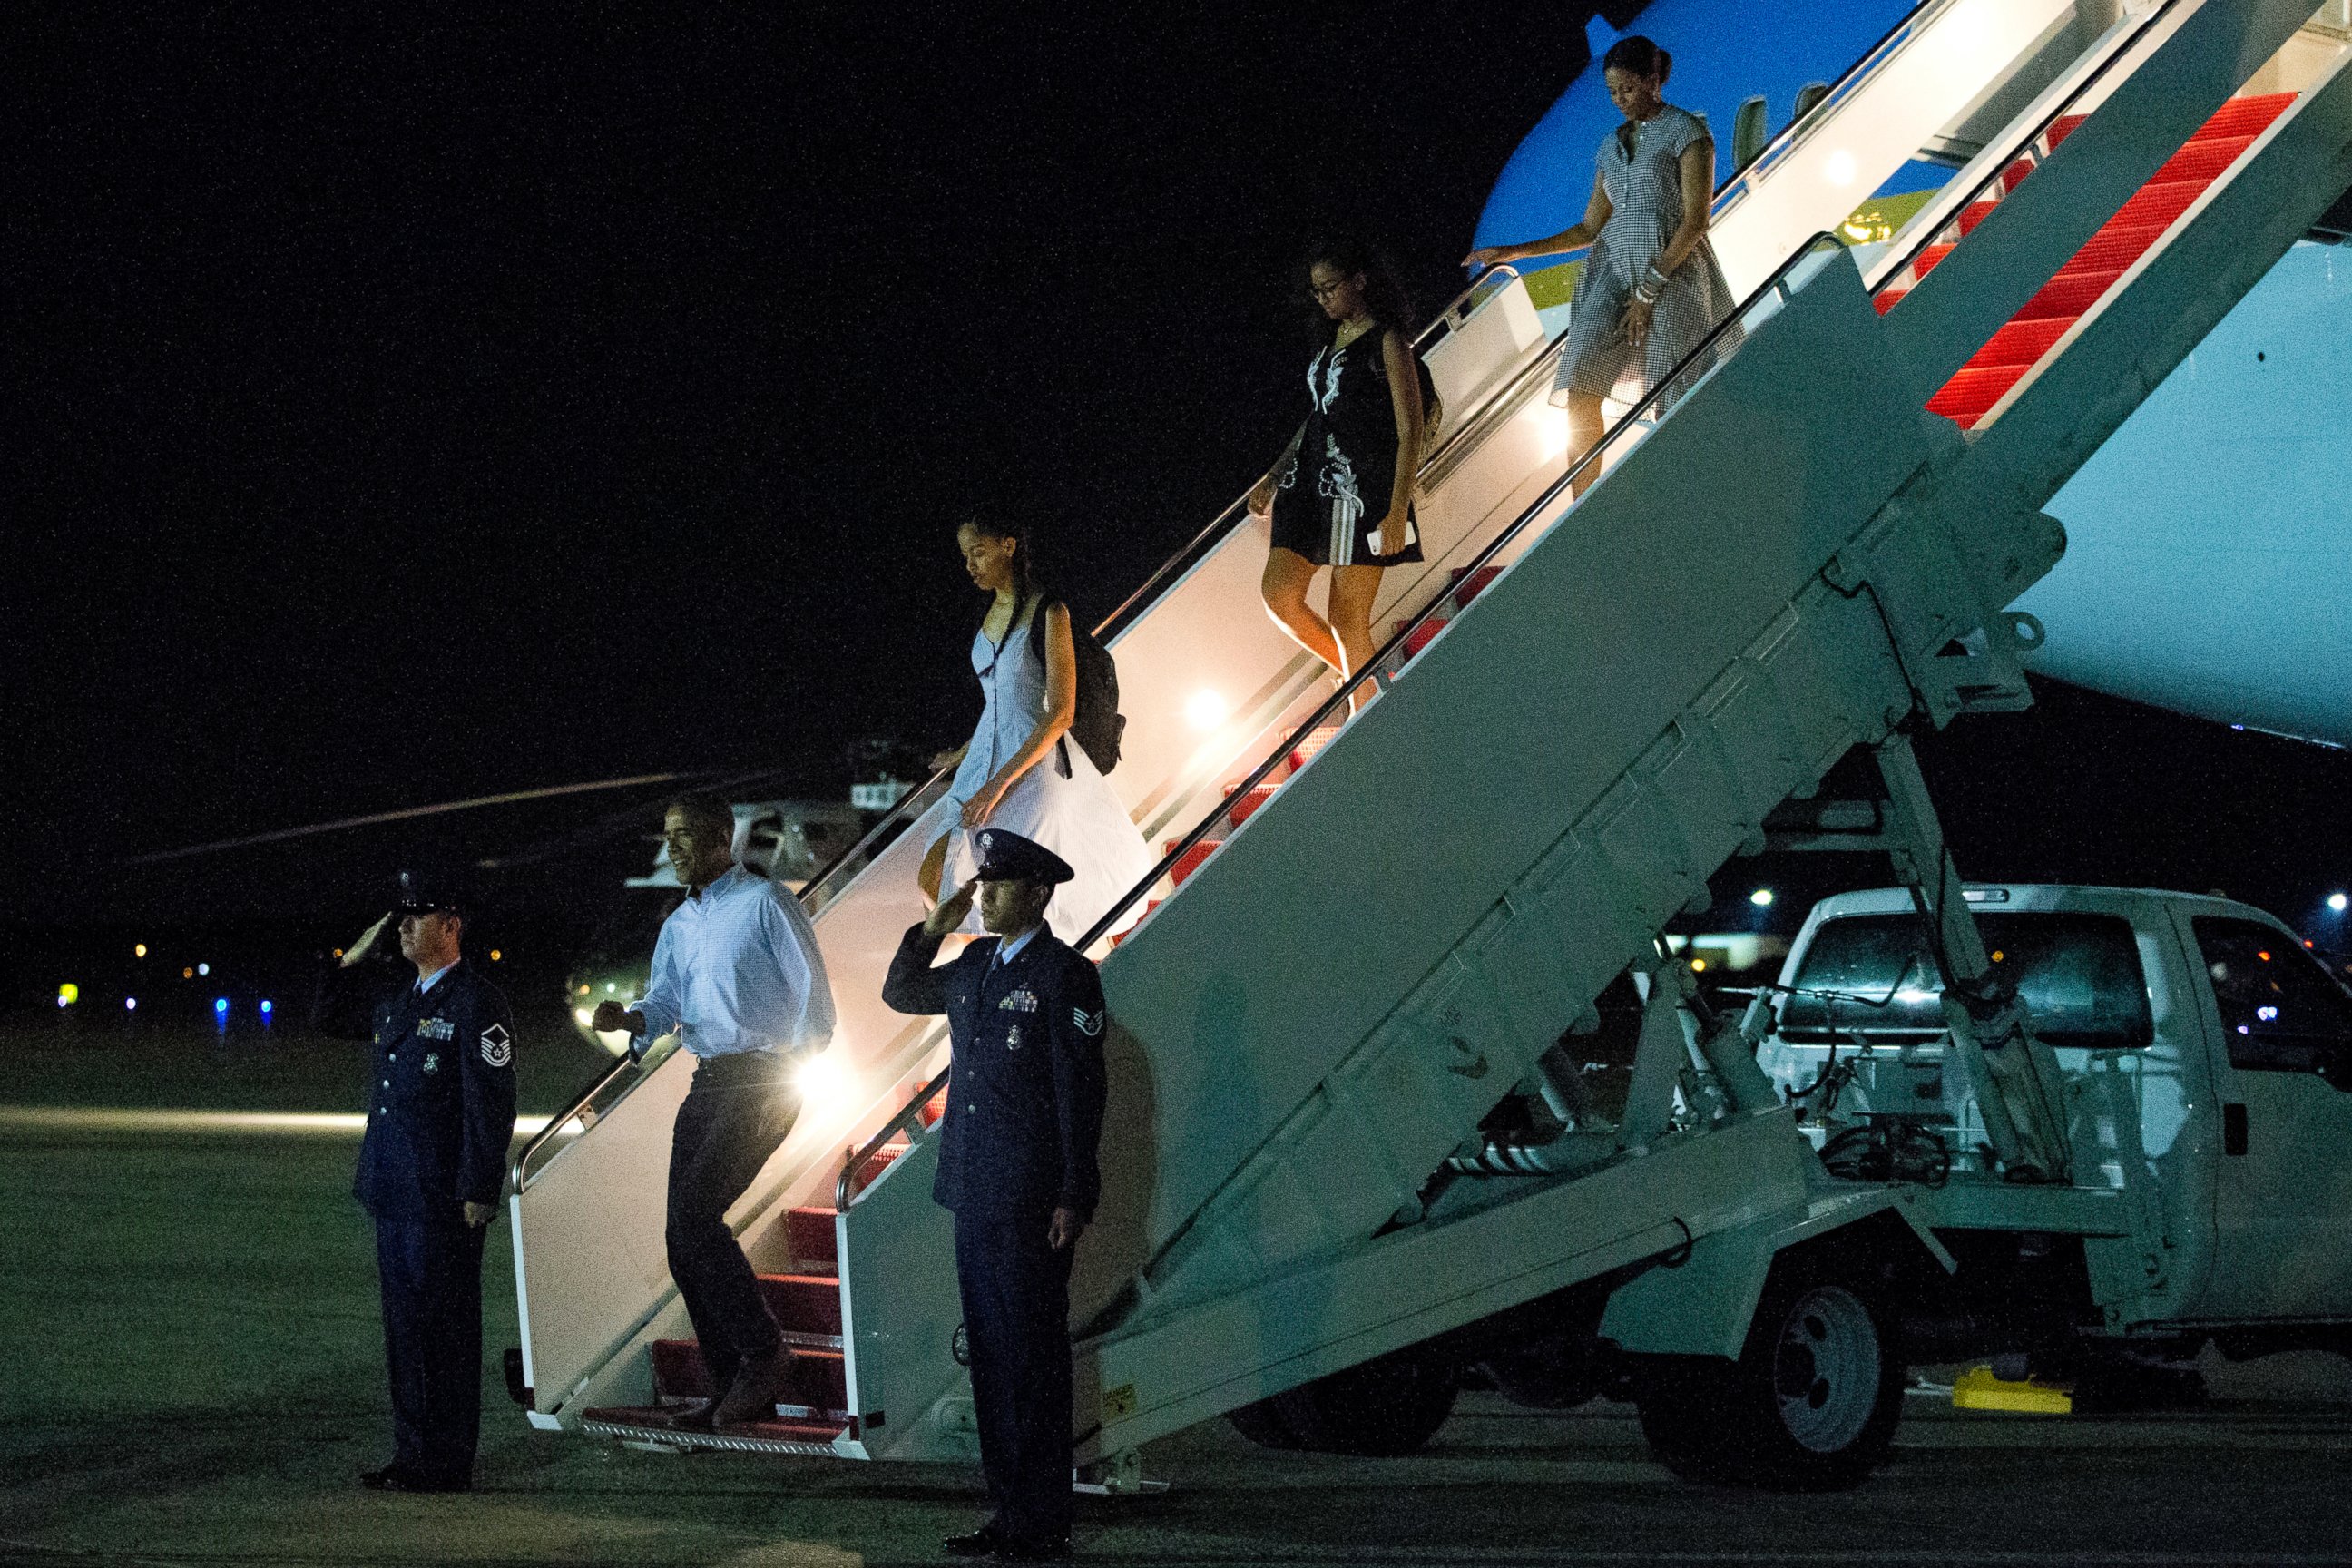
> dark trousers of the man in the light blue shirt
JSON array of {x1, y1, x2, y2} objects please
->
[{"x1": 663, "y1": 1051, "x2": 799, "y2": 1394}]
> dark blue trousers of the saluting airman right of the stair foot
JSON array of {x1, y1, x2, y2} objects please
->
[{"x1": 955, "y1": 1209, "x2": 1075, "y2": 1543}]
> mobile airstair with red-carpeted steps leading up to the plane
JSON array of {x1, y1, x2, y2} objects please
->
[{"x1": 513, "y1": 0, "x2": 2352, "y2": 1479}]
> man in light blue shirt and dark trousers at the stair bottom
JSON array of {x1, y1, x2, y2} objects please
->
[{"x1": 595, "y1": 792, "x2": 833, "y2": 1427}]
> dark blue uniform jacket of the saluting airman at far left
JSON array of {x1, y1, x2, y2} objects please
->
[{"x1": 320, "y1": 959, "x2": 515, "y2": 1222}]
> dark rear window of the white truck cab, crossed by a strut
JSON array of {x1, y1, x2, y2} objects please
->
[{"x1": 1780, "y1": 910, "x2": 2157, "y2": 1051}]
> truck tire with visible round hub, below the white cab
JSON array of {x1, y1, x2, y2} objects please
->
[{"x1": 1637, "y1": 1269, "x2": 1903, "y2": 1493}]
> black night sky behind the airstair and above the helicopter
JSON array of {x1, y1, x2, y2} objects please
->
[{"x1": 0, "y1": 0, "x2": 2347, "y2": 940}]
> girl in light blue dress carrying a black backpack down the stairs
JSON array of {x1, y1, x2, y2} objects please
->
[{"x1": 919, "y1": 517, "x2": 1155, "y2": 943}]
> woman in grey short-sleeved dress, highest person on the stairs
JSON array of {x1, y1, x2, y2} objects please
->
[{"x1": 1465, "y1": 35, "x2": 1738, "y2": 491}]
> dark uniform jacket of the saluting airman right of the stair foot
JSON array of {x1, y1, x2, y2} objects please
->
[{"x1": 882, "y1": 926, "x2": 1105, "y2": 1220}]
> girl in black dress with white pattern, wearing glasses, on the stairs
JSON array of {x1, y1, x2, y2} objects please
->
[{"x1": 1249, "y1": 244, "x2": 1427, "y2": 701}]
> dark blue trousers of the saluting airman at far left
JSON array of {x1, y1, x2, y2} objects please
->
[{"x1": 377, "y1": 1218, "x2": 489, "y2": 1484}]
